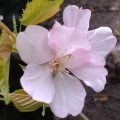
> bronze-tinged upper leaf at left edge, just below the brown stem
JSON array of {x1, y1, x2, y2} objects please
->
[{"x1": 0, "y1": 31, "x2": 13, "y2": 66}]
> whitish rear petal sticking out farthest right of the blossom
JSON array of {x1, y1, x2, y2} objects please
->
[{"x1": 87, "y1": 27, "x2": 117, "y2": 57}]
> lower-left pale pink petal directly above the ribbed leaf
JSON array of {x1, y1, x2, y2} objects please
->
[{"x1": 21, "y1": 64, "x2": 55, "y2": 103}]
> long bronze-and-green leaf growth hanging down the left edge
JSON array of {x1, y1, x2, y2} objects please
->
[{"x1": 0, "y1": 31, "x2": 13, "y2": 104}]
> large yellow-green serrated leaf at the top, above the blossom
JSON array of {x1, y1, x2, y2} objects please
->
[{"x1": 20, "y1": 0, "x2": 63, "y2": 26}]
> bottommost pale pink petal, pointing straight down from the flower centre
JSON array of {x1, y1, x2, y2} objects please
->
[{"x1": 50, "y1": 73, "x2": 86, "y2": 118}]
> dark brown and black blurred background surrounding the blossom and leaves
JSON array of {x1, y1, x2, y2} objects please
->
[{"x1": 0, "y1": 0, "x2": 120, "y2": 120}]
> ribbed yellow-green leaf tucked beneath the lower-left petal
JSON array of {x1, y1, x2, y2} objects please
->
[{"x1": 10, "y1": 89, "x2": 44, "y2": 112}]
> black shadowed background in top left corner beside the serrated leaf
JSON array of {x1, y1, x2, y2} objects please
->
[{"x1": 0, "y1": 0, "x2": 28, "y2": 30}]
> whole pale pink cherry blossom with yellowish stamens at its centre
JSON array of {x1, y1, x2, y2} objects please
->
[{"x1": 16, "y1": 6, "x2": 116, "y2": 118}]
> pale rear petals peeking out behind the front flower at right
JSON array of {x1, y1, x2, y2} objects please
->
[{"x1": 62, "y1": 5, "x2": 117, "y2": 92}]
